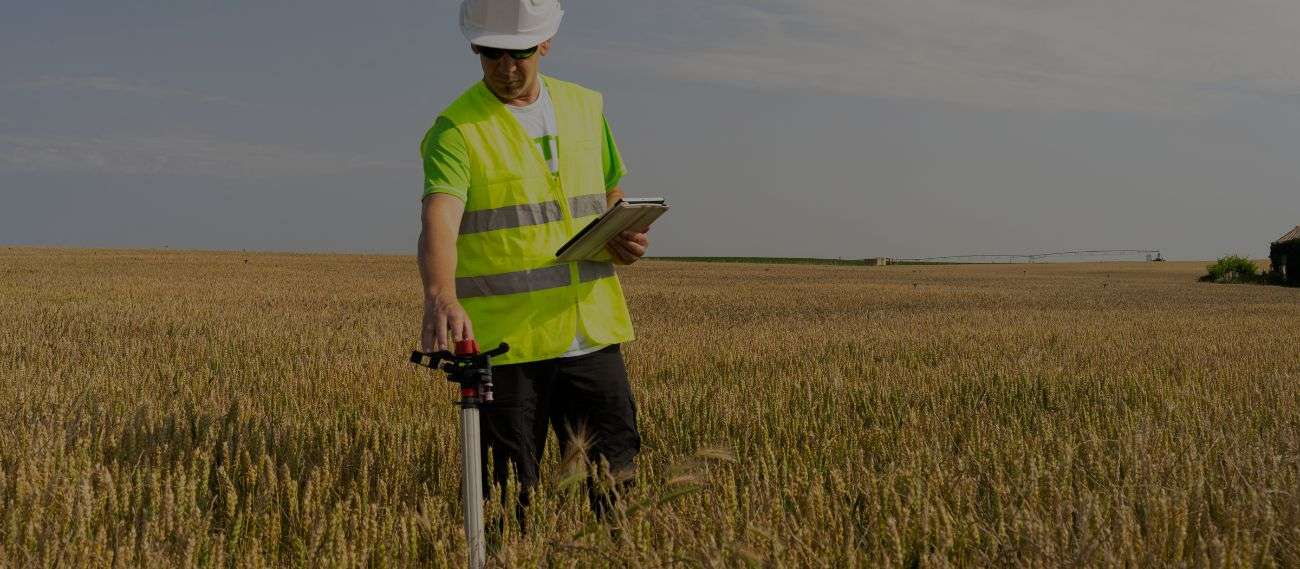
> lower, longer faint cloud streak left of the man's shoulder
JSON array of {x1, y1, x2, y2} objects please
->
[{"x1": 0, "y1": 134, "x2": 410, "y2": 178}]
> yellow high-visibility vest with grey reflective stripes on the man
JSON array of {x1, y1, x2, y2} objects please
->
[{"x1": 442, "y1": 77, "x2": 633, "y2": 364}]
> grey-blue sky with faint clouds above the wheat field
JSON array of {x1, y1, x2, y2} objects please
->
[{"x1": 0, "y1": 0, "x2": 1300, "y2": 260}]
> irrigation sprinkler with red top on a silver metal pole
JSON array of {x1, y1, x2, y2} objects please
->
[{"x1": 411, "y1": 340, "x2": 510, "y2": 569}]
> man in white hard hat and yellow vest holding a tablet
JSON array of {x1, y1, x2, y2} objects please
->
[{"x1": 419, "y1": 0, "x2": 649, "y2": 522}]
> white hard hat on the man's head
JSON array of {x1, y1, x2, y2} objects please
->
[{"x1": 460, "y1": 0, "x2": 564, "y2": 49}]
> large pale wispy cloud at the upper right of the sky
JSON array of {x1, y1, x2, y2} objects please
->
[{"x1": 602, "y1": 0, "x2": 1300, "y2": 113}]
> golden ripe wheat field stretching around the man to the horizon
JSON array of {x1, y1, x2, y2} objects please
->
[{"x1": 0, "y1": 248, "x2": 1300, "y2": 568}]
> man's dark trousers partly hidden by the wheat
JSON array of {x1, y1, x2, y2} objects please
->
[{"x1": 480, "y1": 344, "x2": 641, "y2": 521}]
